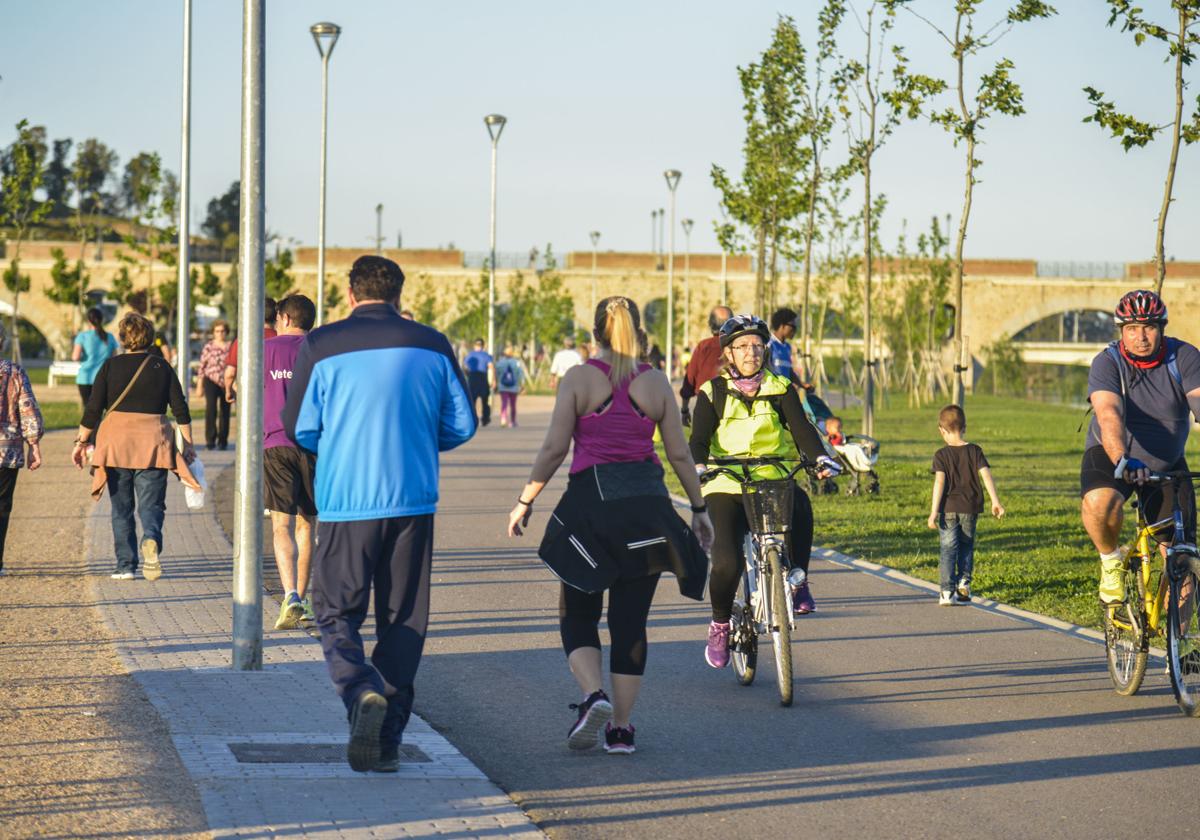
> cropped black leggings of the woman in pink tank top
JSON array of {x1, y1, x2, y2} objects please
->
[{"x1": 558, "y1": 574, "x2": 659, "y2": 677}]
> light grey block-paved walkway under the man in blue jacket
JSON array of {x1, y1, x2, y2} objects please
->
[{"x1": 87, "y1": 451, "x2": 542, "y2": 838}]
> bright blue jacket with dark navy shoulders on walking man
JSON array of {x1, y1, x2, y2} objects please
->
[{"x1": 282, "y1": 304, "x2": 475, "y2": 522}]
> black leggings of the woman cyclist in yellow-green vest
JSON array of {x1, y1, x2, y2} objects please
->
[{"x1": 704, "y1": 487, "x2": 812, "y2": 624}]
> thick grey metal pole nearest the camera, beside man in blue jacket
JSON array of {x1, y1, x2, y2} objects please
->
[{"x1": 233, "y1": 0, "x2": 266, "y2": 671}]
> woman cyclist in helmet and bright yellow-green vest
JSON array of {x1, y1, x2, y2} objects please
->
[{"x1": 691, "y1": 314, "x2": 840, "y2": 668}]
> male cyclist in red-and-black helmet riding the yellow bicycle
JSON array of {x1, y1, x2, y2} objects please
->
[{"x1": 1080, "y1": 289, "x2": 1200, "y2": 604}]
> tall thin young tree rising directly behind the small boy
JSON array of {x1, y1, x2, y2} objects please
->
[{"x1": 906, "y1": 0, "x2": 1056, "y2": 406}]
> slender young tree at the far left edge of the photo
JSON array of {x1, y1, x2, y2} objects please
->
[{"x1": 0, "y1": 120, "x2": 53, "y2": 364}]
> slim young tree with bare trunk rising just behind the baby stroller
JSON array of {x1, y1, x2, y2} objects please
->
[{"x1": 838, "y1": 0, "x2": 944, "y2": 434}]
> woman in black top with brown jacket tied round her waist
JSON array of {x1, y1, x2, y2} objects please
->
[{"x1": 71, "y1": 312, "x2": 200, "y2": 581}]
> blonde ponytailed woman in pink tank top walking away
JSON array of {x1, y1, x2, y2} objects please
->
[{"x1": 509, "y1": 296, "x2": 713, "y2": 754}]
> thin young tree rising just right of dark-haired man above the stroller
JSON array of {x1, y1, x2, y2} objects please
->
[{"x1": 800, "y1": 0, "x2": 846, "y2": 382}]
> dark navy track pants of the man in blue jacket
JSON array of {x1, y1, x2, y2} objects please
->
[{"x1": 312, "y1": 514, "x2": 433, "y2": 744}]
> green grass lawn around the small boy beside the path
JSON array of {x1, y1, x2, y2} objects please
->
[{"x1": 667, "y1": 395, "x2": 1198, "y2": 626}]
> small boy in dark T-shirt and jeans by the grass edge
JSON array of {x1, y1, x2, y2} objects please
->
[{"x1": 929, "y1": 406, "x2": 1004, "y2": 606}]
